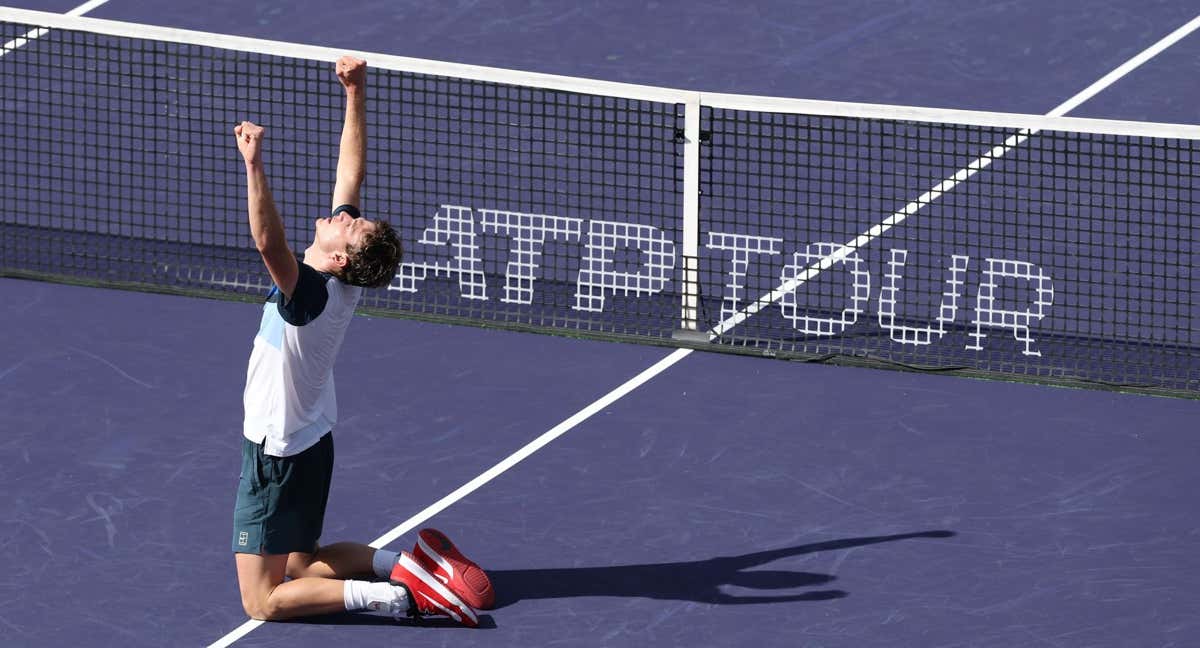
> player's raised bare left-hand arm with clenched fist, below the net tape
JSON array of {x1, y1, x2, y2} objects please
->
[{"x1": 233, "y1": 121, "x2": 300, "y2": 299}]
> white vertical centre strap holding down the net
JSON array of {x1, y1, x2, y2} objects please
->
[{"x1": 672, "y1": 92, "x2": 708, "y2": 342}]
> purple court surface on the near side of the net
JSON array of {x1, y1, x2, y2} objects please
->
[{"x1": 0, "y1": 280, "x2": 1200, "y2": 646}]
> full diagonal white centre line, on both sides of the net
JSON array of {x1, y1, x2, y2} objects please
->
[{"x1": 199, "y1": 10, "x2": 1200, "y2": 648}]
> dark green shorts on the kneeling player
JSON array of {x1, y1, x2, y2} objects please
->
[{"x1": 233, "y1": 432, "x2": 334, "y2": 553}]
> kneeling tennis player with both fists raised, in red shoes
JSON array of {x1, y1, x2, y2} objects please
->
[{"x1": 233, "y1": 56, "x2": 494, "y2": 626}]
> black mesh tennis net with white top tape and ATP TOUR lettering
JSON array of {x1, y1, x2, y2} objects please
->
[{"x1": 0, "y1": 10, "x2": 1200, "y2": 397}]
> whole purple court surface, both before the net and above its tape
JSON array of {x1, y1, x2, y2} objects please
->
[{"x1": 0, "y1": 0, "x2": 1200, "y2": 647}]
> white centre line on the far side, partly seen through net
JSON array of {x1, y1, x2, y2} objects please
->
[{"x1": 708, "y1": 16, "x2": 1200, "y2": 341}]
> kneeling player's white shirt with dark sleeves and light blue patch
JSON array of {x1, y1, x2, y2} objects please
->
[{"x1": 242, "y1": 263, "x2": 362, "y2": 457}]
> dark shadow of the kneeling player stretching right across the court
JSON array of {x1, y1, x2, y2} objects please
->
[{"x1": 487, "y1": 530, "x2": 955, "y2": 608}]
